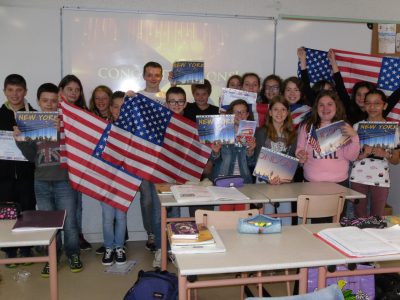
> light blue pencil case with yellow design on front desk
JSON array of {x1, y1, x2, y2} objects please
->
[{"x1": 237, "y1": 215, "x2": 282, "y2": 234}]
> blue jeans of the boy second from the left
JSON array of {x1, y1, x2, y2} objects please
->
[{"x1": 35, "y1": 180, "x2": 79, "y2": 257}]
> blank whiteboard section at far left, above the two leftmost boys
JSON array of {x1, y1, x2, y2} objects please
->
[{"x1": 0, "y1": 6, "x2": 61, "y2": 108}]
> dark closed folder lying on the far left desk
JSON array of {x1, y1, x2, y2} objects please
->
[{"x1": 11, "y1": 210, "x2": 66, "y2": 232}]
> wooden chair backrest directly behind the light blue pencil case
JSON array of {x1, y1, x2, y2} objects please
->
[{"x1": 194, "y1": 209, "x2": 259, "y2": 229}]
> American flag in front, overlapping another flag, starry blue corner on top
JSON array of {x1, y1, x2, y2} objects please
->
[{"x1": 101, "y1": 94, "x2": 211, "y2": 183}]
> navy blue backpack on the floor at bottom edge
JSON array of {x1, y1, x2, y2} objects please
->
[{"x1": 124, "y1": 270, "x2": 178, "y2": 300}]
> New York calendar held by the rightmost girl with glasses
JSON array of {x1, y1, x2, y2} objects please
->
[{"x1": 357, "y1": 121, "x2": 398, "y2": 149}]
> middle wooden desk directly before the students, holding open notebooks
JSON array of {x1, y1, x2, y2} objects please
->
[{"x1": 159, "y1": 182, "x2": 365, "y2": 270}]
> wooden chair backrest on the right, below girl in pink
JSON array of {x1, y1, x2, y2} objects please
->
[{"x1": 297, "y1": 194, "x2": 344, "y2": 224}]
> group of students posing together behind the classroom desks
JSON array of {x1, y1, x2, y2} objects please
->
[{"x1": 0, "y1": 48, "x2": 400, "y2": 277}]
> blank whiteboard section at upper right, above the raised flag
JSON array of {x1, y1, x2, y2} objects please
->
[{"x1": 275, "y1": 20, "x2": 372, "y2": 78}]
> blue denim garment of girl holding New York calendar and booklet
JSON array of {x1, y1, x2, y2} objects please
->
[{"x1": 211, "y1": 145, "x2": 255, "y2": 183}]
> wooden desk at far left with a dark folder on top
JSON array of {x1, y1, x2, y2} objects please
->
[{"x1": 0, "y1": 220, "x2": 58, "y2": 300}]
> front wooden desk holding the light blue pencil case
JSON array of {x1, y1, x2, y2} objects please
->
[{"x1": 176, "y1": 225, "x2": 345, "y2": 300}]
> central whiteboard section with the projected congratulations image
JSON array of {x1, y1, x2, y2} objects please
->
[{"x1": 62, "y1": 9, "x2": 274, "y2": 104}]
